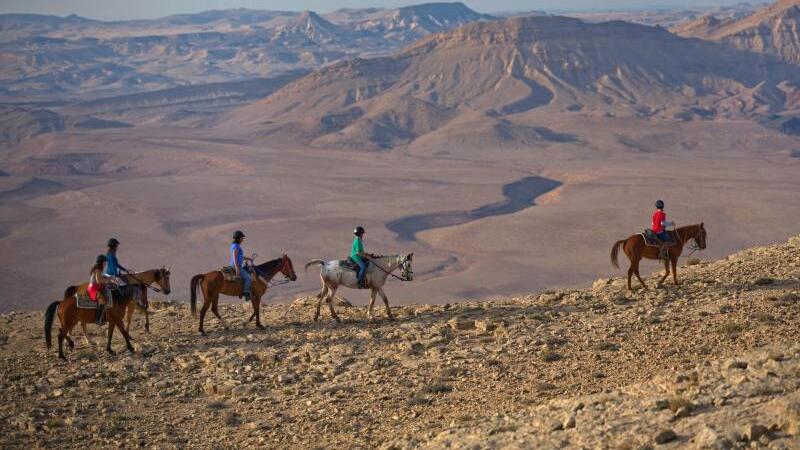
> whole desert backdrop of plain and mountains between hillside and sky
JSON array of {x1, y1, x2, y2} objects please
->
[{"x1": 0, "y1": 1, "x2": 800, "y2": 311}]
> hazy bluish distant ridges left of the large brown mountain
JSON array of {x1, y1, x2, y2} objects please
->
[{"x1": 0, "y1": 3, "x2": 491, "y2": 100}]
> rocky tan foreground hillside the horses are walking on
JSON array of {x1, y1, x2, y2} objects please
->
[{"x1": 0, "y1": 236, "x2": 800, "y2": 449}]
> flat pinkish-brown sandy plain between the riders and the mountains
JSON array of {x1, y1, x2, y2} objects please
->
[{"x1": 0, "y1": 109, "x2": 800, "y2": 311}]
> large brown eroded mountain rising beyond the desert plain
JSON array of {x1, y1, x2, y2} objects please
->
[{"x1": 223, "y1": 17, "x2": 800, "y2": 148}]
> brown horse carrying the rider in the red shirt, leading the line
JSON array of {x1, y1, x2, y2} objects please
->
[{"x1": 611, "y1": 223, "x2": 706, "y2": 291}]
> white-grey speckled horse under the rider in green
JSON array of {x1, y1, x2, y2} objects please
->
[{"x1": 306, "y1": 253, "x2": 414, "y2": 322}]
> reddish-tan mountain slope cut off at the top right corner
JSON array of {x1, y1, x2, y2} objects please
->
[{"x1": 673, "y1": 0, "x2": 800, "y2": 64}]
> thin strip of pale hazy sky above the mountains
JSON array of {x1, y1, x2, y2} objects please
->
[{"x1": 0, "y1": 0, "x2": 756, "y2": 20}]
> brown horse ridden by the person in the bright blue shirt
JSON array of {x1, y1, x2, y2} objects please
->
[{"x1": 189, "y1": 255, "x2": 297, "y2": 335}]
